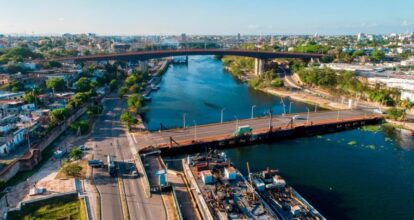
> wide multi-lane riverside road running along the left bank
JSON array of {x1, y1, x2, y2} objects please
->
[{"x1": 91, "y1": 94, "x2": 166, "y2": 220}]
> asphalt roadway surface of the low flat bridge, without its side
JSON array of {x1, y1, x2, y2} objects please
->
[{"x1": 137, "y1": 110, "x2": 378, "y2": 148}]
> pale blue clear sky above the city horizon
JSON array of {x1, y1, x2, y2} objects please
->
[{"x1": 0, "y1": 0, "x2": 414, "y2": 35}]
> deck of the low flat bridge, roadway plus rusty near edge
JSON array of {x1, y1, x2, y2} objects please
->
[{"x1": 138, "y1": 110, "x2": 382, "y2": 152}]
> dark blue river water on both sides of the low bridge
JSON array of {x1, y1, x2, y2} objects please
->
[{"x1": 144, "y1": 56, "x2": 414, "y2": 219}]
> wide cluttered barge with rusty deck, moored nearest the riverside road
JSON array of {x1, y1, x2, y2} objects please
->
[{"x1": 183, "y1": 151, "x2": 278, "y2": 220}]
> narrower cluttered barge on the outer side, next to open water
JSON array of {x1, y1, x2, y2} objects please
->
[{"x1": 249, "y1": 169, "x2": 326, "y2": 220}]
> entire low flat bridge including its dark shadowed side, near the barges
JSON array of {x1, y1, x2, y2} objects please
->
[{"x1": 136, "y1": 110, "x2": 383, "y2": 154}]
